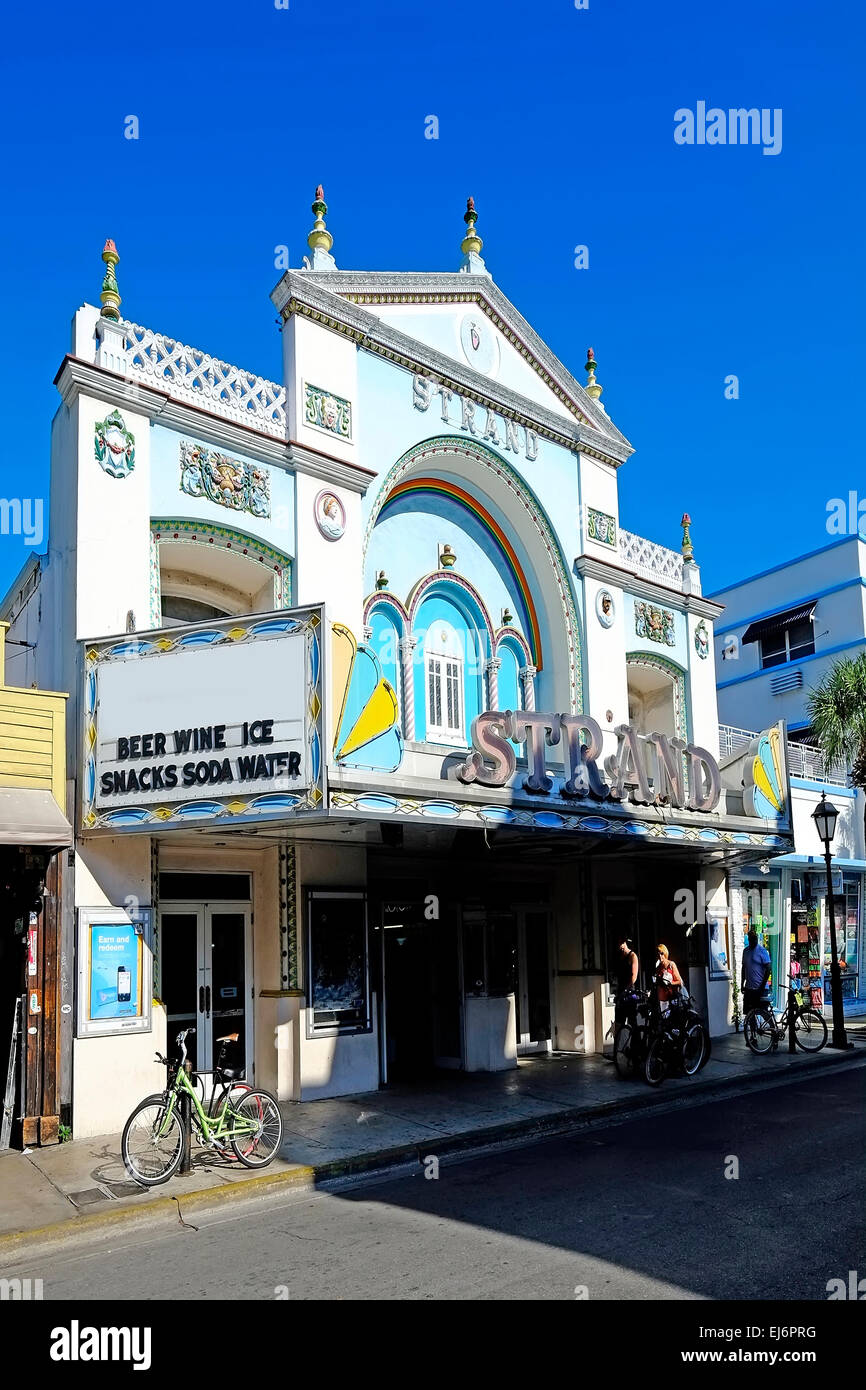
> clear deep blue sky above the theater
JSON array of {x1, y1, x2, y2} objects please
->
[{"x1": 0, "y1": 0, "x2": 866, "y2": 592}]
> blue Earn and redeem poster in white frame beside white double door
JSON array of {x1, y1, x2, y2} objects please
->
[{"x1": 78, "y1": 908, "x2": 152, "y2": 1037}]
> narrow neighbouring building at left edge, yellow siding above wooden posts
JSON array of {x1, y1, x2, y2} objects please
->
[{"x1": 0, "y1": 623, "x2": 72, "y2": 1148}]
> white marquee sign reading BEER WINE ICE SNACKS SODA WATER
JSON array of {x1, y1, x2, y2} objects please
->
[{"x1": 82, "y1": 609, "x2": 322, "y2": 828}]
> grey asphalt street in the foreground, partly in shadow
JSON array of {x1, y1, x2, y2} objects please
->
[{"x1": 3, "y1": 1065, "x2": 866, "y2": 1302}]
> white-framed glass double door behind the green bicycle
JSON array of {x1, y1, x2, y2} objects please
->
[{"x1": 160, "y1": 904, "x2": 253, "y2": 1079}]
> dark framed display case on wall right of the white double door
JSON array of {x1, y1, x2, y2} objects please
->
[{"x1": 307, "y1": 891, "x2": 370, "y2": 1033}]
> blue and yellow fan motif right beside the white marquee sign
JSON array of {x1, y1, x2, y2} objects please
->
[{"x1": 331, "y1": 623, "x2": 403, "y2": 773}]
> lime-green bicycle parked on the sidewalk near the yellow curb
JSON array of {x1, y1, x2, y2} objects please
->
[{"x1": 121, "y1": 1029, "x2": 282, "y2": 1187}]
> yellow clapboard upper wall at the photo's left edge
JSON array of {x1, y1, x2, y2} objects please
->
[{"x1": 0, "y1": 623, "x2": 67, "y2": 815}]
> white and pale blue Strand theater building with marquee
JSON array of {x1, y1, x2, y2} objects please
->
[{"x1": 0, "y1": 189, "x2": 794, "y2": 1134}]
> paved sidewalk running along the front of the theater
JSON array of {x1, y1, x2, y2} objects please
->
[{"x1": 0, "y1": 1029, "x2": 866, "y2": 1261}]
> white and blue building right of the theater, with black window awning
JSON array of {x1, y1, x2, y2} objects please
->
[{"x1": 713, "y1": 535, "x2": 866, "y2": 1009}]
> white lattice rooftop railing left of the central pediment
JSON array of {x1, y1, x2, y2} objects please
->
[{"x1": 124, "y1": 324, "x2": 286, "y2": 438}]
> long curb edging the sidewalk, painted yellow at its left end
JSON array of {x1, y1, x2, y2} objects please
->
[{"x1": 0, "y1": 1048, "x2": 863, "y2": 1262}]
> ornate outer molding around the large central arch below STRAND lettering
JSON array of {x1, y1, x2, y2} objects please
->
[{"x1": 363, "y1": 435, "x2": 584, "y2": 700}]
